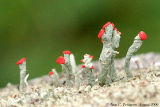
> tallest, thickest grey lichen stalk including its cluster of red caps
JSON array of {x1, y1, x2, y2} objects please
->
[{"x1": 98, "y1": 22, "x2": 121, "y2": 86}]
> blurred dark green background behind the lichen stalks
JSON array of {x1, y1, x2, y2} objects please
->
[{"x1": 0, "y1": 0, "x2": 160, "y2": 87}]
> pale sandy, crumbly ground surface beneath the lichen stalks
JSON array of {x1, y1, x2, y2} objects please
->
[{"x1": 0, "y1": 53, "x2": 160, "y2": 107}]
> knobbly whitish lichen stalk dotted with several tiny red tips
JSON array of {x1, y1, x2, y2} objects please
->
[{"x1": 81, "y1": 54, "x2": 95, "y2": 87}]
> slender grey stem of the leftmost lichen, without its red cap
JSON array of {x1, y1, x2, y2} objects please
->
[{"x1": 19, "y1": 61, "x2": 26, "y2": 92}]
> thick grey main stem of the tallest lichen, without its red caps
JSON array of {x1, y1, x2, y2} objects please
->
[{"x1": 98, "y1": 24, "x2": 119, "y2": 86}]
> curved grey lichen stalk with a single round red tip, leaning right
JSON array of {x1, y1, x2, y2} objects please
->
[{"x1": 125, "y1": 31, "x2": 147, "y2": 78}]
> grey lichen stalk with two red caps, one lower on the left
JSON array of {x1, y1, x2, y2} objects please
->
[{"x1": 57, "y1": 51, "x2": 74, "y2": 86}]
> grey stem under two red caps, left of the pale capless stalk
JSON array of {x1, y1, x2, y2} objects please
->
[{"x1": 62, "y1": 54, "x2": 74, "y2": 86}]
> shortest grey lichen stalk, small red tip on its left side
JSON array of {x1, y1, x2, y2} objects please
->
[{"x1": 49, "y1": 69, "x2": 61, "y2": 87}]
